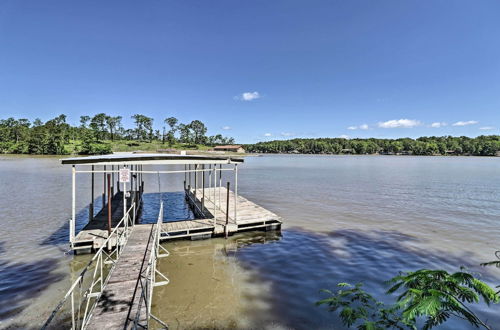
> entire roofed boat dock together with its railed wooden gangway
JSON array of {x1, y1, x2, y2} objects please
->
[{"x1": 42, "y1": 153, "x2": 282, "y2": 330}]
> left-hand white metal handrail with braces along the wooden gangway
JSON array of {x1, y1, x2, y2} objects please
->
[{"x1": 42, "y1": 203, "x2": 136, "y2": 330}]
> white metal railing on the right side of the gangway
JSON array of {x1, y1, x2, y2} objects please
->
[{"x1": 134, "y1": 201, "x2": 170, "y2": 329}]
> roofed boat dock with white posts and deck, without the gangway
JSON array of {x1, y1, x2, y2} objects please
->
[{"x1": 62, "y1": 154, "x2": 281, "y2": 252}]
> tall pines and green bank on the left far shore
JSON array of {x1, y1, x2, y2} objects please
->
[{"x1": 0, "y1": 113, "x2": 234, "y2": 155}]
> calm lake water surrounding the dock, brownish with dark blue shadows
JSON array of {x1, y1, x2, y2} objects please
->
[{"x1": 0, "y1": 156, "x2": 500, "y2": 329}]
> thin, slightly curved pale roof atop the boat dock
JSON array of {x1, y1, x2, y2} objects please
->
[{"x1": 61, "y1": 153, "x2": 243, "y2": 165}]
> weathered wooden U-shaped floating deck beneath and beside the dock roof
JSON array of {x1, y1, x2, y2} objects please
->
[{"x1": 73, "y1": 187, "x2": 281, "y2": 253}]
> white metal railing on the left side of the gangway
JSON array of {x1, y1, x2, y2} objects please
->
[{"x1": 42, "y1": 202, "x2": 137, "y2": 330}]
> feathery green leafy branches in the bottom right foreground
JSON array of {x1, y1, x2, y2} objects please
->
[{"x1": 317, "y1": 268, "x2": 500, "y2": 329}]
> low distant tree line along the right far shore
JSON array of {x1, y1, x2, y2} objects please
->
[{"x1": 245, "y1": 135, "x2": 500, "y2": 156}]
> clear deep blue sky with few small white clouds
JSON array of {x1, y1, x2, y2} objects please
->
[{"x1": 0, "y1": 0, "x2": 500, "y2": 143}]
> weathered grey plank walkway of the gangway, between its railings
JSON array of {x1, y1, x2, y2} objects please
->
[{"x1": 87, "y1": 225, "x2": 154, "y2": 330}]
